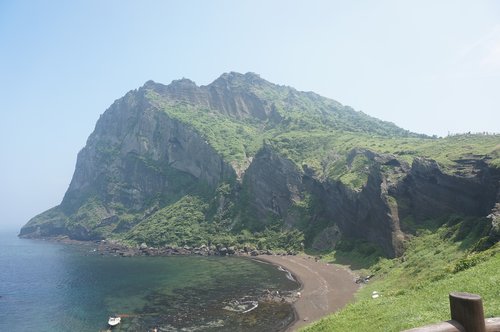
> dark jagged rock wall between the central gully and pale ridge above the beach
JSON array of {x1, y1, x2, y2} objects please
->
[{"x1": 240, "y1": 147, "x2": 404, "y2": 256}]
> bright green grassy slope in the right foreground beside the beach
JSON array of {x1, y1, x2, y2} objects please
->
[{"x1": 304, "y1": 220, "x2": 500, "y2": 332}]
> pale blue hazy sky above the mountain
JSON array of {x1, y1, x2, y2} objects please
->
[{"x1": 0, "y1": 0, "x2": 500, "y2": 228}]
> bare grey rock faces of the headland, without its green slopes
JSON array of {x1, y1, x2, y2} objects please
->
[{"x1": 21, "y1": 73, "x2": 500, "y2": 256}]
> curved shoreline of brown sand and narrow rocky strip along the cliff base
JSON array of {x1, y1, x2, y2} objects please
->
[{"x1": 27, "y1": 237, "x2": 359, "y2": 331}]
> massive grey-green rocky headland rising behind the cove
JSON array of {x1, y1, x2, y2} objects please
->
[{"x1": 20, "y1": 73, "x2": 500, "y2": 256}]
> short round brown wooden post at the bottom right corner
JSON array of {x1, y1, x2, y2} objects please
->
[{"x1": 450, "y1": 292, "x2": 486, "y2": 332}]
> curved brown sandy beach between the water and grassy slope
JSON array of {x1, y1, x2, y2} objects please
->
[{"x1": 257, "y1": 255, "x2": 359, "y2": 331}]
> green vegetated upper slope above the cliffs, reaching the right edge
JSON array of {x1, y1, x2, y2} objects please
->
[{"x1": 147, "y1": 81, "x2": 500, "y2": 190}]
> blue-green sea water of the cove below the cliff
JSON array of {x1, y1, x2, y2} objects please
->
[{"x1": 0, "y1": 232, "x2": 298, "y2": 332}]
